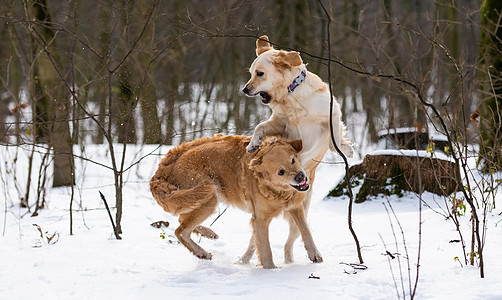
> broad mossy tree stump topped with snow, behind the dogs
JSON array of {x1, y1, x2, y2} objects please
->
[{"x1": 328, "y1": 150, "x2": 460, "y2": 203}]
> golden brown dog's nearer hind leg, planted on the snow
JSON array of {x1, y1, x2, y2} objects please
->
[{"x1": 174, "y1": 188, "x2": 218, "y2": 259}]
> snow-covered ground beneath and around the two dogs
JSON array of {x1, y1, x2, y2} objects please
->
[{"x1": 0, "y1": 145, "x2": 502, "y2": 299}]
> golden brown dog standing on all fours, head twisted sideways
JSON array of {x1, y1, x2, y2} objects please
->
[{"x1": 150, "y1": 135, "x2": 322, "y2": 268}]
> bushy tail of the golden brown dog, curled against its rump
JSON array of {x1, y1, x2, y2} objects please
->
[{"x1": 150, "y1": 176, "x2": 216, "y2": 216}]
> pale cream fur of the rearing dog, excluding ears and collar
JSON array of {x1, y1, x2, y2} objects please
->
[{"x1": 246, "y1": 49, "x2": 353, "y2": 165}]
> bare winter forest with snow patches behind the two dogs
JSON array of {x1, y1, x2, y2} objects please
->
[{"x1": 0, "y1": 0, "x2": 502, "y2": 241}]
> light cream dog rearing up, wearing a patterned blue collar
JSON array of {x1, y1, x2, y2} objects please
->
[{"x1": 241, "y1": 35, "x2": 353, "y2": 263}]
